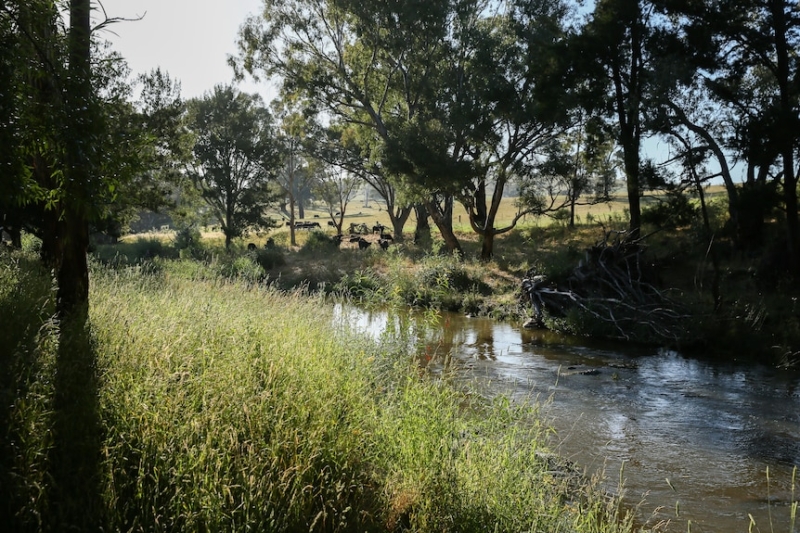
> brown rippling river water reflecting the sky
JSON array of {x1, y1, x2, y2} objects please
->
[{"x1": 338, "y1": 308, "x2": 800, "y2": 533}]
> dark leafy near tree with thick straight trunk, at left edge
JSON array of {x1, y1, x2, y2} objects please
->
[{"x1": 0, "y1": 0, "x2": 180, "y2": 312}]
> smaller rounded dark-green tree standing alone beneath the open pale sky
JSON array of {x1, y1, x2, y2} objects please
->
[{"x1": 187, "y1": 85, "x2": 279, "y2": 248}]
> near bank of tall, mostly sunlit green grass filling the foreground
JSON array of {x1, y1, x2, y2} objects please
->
[{"x1": 0, "y1": 248, "x2": 634, "y2": 532}]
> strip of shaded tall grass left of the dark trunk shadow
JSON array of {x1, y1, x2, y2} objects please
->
[{"x1": 0, "y1": 247, "x2": 58, "y2": 531}]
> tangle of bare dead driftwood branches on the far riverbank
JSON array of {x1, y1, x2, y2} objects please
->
[{"x1": 522, "y1": 231, "x2": 689, "y2": 343}]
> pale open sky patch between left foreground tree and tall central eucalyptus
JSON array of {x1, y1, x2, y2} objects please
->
[{"x1": 92, "y1": 0, "x2": 276, "y2": 103}]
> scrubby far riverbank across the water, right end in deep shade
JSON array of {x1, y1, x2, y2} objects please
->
[{"x1": 96, "y1": 221, "x2": 800, "y2": 367}]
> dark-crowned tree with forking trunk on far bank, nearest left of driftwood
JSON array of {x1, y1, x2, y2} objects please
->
[{"x1": 444, "y1": 0, "x2": 572, "y2": 259}]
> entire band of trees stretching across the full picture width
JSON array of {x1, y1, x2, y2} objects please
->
[{"x1": 0, "y1": 0, "x2": 800, "y2": 309}]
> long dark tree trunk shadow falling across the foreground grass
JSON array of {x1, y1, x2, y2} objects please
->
[{"x1": 47, "y1": 307, "x2": 106, "y2": 531}]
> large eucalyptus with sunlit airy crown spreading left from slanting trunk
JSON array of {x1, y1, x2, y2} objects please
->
[{"x1": 234, "y1": 0, "x2": 476, "y2": 253}]
